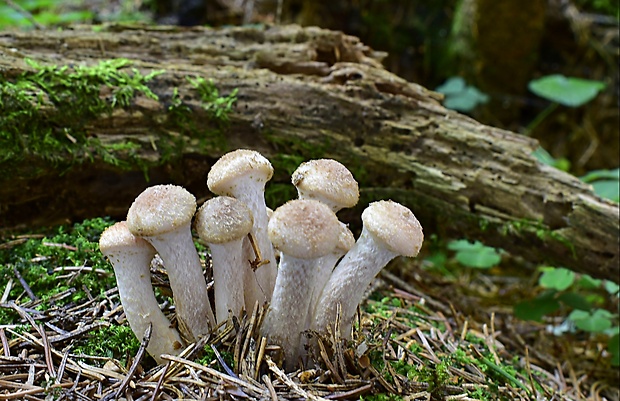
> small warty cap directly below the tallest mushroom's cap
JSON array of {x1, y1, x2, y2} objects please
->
[{"x1": 194, "y1": 196, "x2": 254, "y2": 244}]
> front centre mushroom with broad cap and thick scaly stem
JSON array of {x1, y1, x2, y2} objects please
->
[{"x1": 263, "y1": 200, "x2": 340, "y2": 370}]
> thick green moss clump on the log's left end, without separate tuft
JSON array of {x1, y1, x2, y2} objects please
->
[{"x1": 0, "y1": 59, "x2": 163, "y2": 167}]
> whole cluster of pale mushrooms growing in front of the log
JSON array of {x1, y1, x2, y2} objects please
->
[{"x1": 99, "y1": 149, "x2": 424, "y2": 370}]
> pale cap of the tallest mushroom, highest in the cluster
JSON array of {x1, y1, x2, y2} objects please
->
[{"x1": 207, "y1": 149, "x2": 273, "y2": 196}]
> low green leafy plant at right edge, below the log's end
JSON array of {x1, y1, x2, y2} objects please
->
[{"x1": 514, "y1": 266, "x2": 620, "y2": 366}]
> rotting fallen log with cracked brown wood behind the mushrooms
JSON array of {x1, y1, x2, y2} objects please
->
[{"x1": 0, "y1": 25, "x2": 619, "y2": 281}]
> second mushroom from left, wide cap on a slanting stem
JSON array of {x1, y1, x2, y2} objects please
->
[{"x1": 127, "y1": 185, "x2": 215, "y2": 341}]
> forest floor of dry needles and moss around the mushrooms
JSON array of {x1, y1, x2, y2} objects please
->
[{"x1": 0, "y1": 219, "x2": 620, "y2": 400}]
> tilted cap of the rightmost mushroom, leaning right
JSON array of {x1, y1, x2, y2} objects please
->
[{"x1": 362, "y1": 200, "x2": 424, "y2": 257}]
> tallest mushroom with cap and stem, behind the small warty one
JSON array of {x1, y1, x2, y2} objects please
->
[{"x1": 207, "y1": 149, "x2": 277, "y2": 310}]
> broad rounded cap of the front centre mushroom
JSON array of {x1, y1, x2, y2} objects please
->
[{"x1": 267, "y1": 199, "x2": 340, "y2": 259}]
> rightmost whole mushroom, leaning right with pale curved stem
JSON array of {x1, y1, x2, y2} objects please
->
[{"x1": 313, "y1": 201, "x2": 424, "y2": 338}]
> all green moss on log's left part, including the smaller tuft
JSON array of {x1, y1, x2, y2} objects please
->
[{"x1": 0, "y1": 59, "x2": 237, "y2": 176}]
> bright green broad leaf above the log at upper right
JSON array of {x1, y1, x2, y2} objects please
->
[{"x1": 528, "y1": 74, "x2": 605, "y2": 107}]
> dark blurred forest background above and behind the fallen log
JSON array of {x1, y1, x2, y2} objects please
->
[{"x1": 0, "y1": 0, "x2": 620, "y2": 181}]
